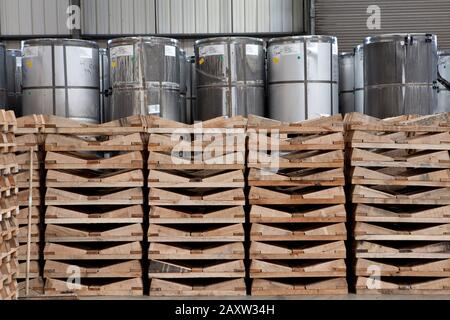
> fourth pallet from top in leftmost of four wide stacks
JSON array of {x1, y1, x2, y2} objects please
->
[{"x1": 46, "y1": 170, "x2": 144, "y2": 188}]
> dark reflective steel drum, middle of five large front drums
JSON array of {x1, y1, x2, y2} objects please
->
[{"x1": 195, "y1": 37, "x2": 265, "y2": 120}]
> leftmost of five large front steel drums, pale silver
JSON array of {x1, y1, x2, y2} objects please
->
[{"x1": 22, "y1": 39, "x2": 100, "y2": 123}]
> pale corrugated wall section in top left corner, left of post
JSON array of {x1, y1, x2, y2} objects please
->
[{"x1": 0, "y1": 0, "x2": 70, "y2": 36}]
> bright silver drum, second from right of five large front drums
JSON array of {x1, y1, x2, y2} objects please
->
[{"x1": 267, "y1": 36, "x2": 339, "y2": 122}]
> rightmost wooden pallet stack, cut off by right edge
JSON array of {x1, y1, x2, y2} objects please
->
[{"x1": 346, "y1": 114, "x2": 450, "y2": 294}]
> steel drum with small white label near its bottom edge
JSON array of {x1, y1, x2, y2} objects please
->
[{"x1": 108, "y1": 37, "x2": 181, "y2": 121}]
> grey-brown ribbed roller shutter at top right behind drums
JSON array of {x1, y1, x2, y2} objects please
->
[{"x1": 315, "y1": 0, "x2": 450, "y2": 51}]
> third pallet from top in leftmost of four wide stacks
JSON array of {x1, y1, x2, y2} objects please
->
[{"x1": 45, "y1": 151, "x2": 143, "y2": 170}]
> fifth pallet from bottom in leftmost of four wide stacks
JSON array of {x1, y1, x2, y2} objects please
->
[{"x1": 45, "y1": 205, "x2": 144, "y2": 225}]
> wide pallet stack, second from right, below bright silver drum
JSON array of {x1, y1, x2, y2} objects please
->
[{"x1": 247, "y1": 116, "x2": 347, "y2": 296}]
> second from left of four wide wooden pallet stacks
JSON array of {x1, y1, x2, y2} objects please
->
[{"x1": 148, "y1": 117, "x2": 246, "y2": 296}]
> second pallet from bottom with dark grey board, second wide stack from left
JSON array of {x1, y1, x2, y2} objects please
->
[{"x1": 148, "y1": 260, "x2": 245, "y2": 279}]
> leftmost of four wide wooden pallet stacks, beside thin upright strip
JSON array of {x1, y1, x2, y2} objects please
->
[{"x1": 44, "y1": 117, "x2": 144, "y2": 296}]
